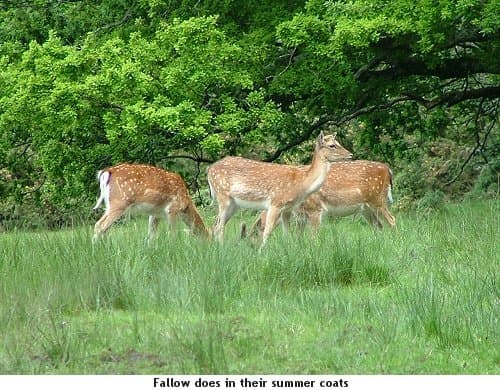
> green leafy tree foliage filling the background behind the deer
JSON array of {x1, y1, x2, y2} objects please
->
[{"x1": 0, "y1": 0, "x2": 500, "y2": 224}]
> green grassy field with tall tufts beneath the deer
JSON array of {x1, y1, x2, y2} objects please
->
[{"x1": 0, "y1": 201, "x2": 500, "y2": 374}]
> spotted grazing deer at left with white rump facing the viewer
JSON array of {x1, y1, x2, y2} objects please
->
[{"x1": 93, "y1": 164, "x2": 209, "y2": 242}]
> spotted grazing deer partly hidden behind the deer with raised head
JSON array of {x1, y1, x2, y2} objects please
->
[{"x1": 245, "y1": 160, "x2": 396, "y2": 237}]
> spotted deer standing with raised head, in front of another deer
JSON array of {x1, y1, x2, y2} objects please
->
[{"x1": 208, "y1": 133, "x2": 352, "y2": 246}]
